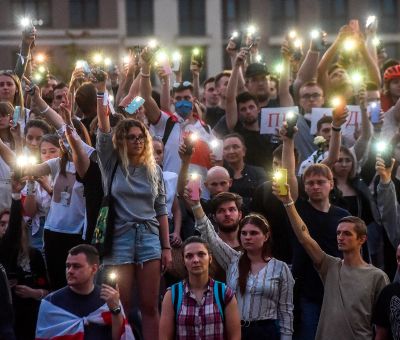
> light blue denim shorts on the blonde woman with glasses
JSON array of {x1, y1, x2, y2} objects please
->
[{"x1": 103, "y1": 223, "x2": 161, "y2": 266}]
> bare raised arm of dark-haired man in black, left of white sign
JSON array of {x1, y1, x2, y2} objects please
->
[{"x1": 225, "y1": 50, "x2": 248, "y2": 131}]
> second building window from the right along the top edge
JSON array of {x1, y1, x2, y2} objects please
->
[{"x1": 320, "y1": 0, "x2": 349, "y2": 33}]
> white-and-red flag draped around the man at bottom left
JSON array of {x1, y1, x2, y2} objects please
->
[{"x1": 36, "y1": 300, "x2": 135, "y2": 340}]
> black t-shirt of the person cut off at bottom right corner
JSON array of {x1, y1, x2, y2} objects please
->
[{"x1": 372, "y1": 282, "x2": 400, "y2": 340}]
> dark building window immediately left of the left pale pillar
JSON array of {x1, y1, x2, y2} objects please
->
[{"x1": 126, "y1": 0, "x2": 154, "y2": 36}]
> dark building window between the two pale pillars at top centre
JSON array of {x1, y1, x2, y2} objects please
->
[{"x1": 178, "y1": 0, "x2": 206, "y2": 36}]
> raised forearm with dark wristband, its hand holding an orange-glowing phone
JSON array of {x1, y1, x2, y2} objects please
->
[{"x1": 321, "y1": 108, "x2": 348, "y2": 168}]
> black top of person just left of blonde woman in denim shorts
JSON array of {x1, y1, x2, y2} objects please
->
[{"x1": 76, "y1": 160, "x2": 103, "y2": 243}]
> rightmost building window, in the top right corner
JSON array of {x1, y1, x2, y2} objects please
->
[{"x1": 368, "y1": 0, "x2": 399, "y2": 33}]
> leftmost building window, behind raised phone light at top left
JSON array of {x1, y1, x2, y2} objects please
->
[{"x1": 10, "y1": 0, "x2": 51, "y2": 27}]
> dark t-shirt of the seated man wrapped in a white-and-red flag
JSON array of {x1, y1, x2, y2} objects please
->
[{"x1": 46, "y1": 286, "x2": 112, "y2": 340}]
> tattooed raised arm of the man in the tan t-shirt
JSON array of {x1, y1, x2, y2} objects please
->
[{"x1": 272, "y1": 183, "x2": 325, "y2": 267}]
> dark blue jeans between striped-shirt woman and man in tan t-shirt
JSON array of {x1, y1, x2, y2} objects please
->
[{"x1": 293, "y1": 297, "x2": 321, "y2": 340}]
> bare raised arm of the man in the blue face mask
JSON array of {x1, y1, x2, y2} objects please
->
[{"x1": 140, "y1": 47, "x2": 161, "y2": 124}]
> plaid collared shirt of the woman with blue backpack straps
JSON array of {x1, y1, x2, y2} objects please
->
[{"x1": 176, "y1": 279, "x2": 234, "y2": 340}]
